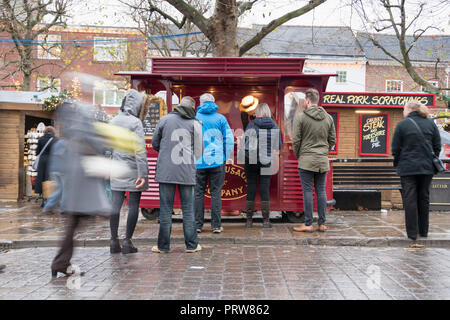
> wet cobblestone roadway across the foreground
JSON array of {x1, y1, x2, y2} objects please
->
[{"x1": 0, "y1": 245, "x2": 450, "y2": 300}]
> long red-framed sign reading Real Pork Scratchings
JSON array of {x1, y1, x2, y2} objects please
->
[{"x1": 322, "y1": 92, "x2": 436, "y2": 108}]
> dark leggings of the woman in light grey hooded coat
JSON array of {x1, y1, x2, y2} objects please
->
[{"x1": 109, "y1": 190, "x2": 141, "y2": 239}]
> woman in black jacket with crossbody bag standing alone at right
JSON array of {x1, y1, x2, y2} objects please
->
[{"x1": 392, "y1": 100, "x2": 441, "y2": 246}]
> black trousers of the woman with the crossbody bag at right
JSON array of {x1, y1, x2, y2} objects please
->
[{"x1": 400, "y1": 175, "x2": 433, "y2": 239}]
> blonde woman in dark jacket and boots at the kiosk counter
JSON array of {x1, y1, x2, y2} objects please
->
[{"x1": 244, "y1": 103, "x2": 281, "y2": 228}]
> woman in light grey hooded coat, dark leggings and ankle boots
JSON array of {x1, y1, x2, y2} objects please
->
[{"x1": 110, "y1": 89, "x2": 150, "y2": 254}]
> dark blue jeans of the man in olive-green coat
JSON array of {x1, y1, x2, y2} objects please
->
[{"x1": 298, "y1": 169, "x2": 327, "y2": 226}]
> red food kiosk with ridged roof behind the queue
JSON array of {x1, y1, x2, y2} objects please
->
[{"x1": 117, "y1": 57, "x2": 336, "y2": 221}]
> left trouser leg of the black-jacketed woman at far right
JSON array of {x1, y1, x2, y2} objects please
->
[{"x1": 400, "y1": 176, "x2": 418, "y2": 240}]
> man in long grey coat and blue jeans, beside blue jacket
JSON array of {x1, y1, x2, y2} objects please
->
[{"x1": 152, "y1": 97, "x2": 203, "y2": 253}]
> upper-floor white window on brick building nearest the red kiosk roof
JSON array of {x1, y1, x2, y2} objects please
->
[{"x1": 94, "y1": 37, "x2": 127, "y2": 61}]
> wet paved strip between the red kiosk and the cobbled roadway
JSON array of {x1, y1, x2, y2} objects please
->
[{"x1": 0, "y1": 202, "x2": 450, "y2": 248}]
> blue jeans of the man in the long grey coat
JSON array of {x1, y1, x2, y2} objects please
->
[{"x1": 158, "y1": 183, "x2": 198, "y2": 251}]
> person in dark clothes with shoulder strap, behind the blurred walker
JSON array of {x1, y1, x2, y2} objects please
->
[{"x1": 34, "y1": 126, "x2": 57, "y2": 202}]
